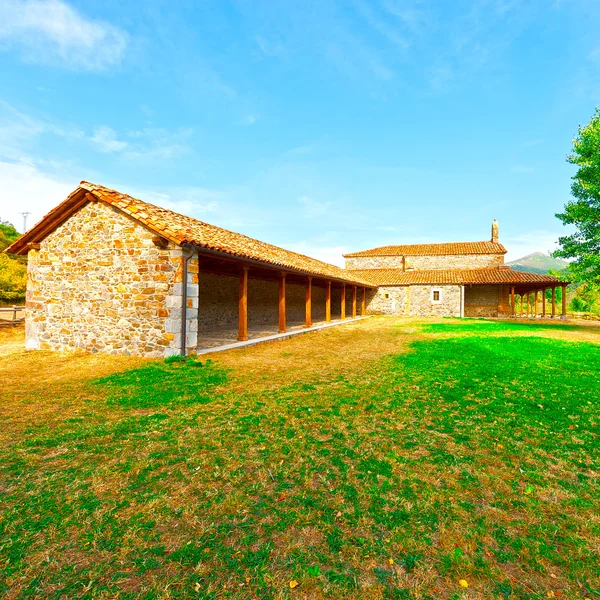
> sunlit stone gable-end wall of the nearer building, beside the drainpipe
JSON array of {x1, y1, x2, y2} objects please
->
[{"x1": 26, "y1": 202, "x2": 198, "y2": 357}]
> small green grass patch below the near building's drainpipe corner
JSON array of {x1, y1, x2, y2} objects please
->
[{"x1": 92, "y1": 358, "x2": 227, "y2": 408}]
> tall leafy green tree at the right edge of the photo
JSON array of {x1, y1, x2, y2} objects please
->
[{"x1": 554, "y1": 108, "x2": 600, "y2": 283}]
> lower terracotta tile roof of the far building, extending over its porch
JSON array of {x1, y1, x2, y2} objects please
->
[{"x1": 353, "y1": 267, "x2": 558, "y2": 286}]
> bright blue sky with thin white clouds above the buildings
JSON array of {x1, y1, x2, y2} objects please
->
[{"x1": 0, "y1": 0, "x2": 600, "y2": 263}]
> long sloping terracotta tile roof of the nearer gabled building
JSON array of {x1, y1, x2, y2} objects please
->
[{"x1": 7, "y1": 181, "x2": 371, "y2": 286}]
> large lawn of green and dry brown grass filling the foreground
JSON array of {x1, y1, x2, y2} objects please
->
[{"x1": 0, "y1": 319, "x2": 600, "y2": 599}]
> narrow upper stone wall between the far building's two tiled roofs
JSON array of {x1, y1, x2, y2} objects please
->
[{"x1": 346, "y1": 254, "x2": 504, "y2": 271}]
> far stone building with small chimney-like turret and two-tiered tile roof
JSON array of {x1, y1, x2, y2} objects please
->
[{"x1": 344, "y1": 220, "x2": 566, "y2": 317}]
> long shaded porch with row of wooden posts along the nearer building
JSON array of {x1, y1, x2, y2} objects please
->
[{"x1": 188, "y1": 249, "x2": 371, "y2": 352}]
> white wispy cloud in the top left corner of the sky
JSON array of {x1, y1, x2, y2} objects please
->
[{"x1": 0, "y1": 0, "x2": 127, "y2": 71}]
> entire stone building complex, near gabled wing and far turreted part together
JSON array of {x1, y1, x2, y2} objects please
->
[{"x1": 6, "y1": 182, "x2": 565, "y2": 357}]
